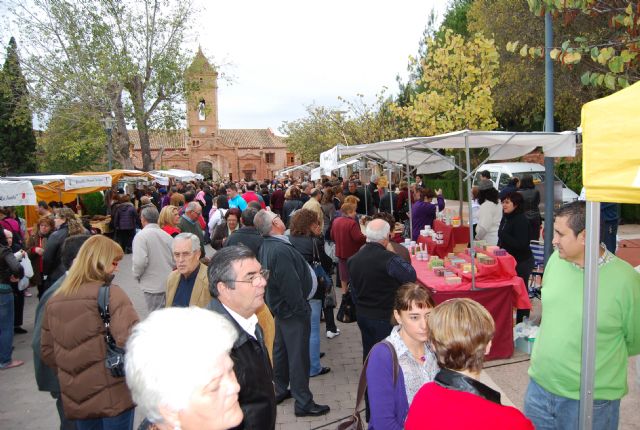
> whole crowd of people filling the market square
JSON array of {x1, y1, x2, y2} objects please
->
[{"x1": 0, "y1": 175, "x2": 640, "y2": 430}]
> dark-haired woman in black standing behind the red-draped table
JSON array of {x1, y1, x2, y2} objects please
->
[{"x1": 498, "y1": 191, "x2": 535, "y2": 322}]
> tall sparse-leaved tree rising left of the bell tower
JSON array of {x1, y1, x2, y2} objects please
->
[{"x1": 10, "y1": 0, "x2": 195, "y2": 170}]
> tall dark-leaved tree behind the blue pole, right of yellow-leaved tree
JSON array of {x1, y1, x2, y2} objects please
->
[{"x1": 468, "y1": 0, "x2": 606, "y2": 131}]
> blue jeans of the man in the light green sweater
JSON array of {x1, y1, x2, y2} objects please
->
[{"x1": 524, "y1": 379, "x2": 620, "y2": 430}]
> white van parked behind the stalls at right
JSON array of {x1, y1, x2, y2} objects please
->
[{"x1": 473, "y1": 163, "x2": 578, "y2": 212}]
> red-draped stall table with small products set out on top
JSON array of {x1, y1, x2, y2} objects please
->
[{"x1": 411, "y1": 247, "x2": 531, "y2": 360}]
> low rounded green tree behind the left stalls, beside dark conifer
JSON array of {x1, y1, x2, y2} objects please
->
[{"x1": 38, "y1": 103, "x2": 106, "y2": 173}]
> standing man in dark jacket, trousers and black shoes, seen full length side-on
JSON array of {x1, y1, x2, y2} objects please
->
[{"x1": 253, "y1": 210, "x2": 329, "y2": 417}]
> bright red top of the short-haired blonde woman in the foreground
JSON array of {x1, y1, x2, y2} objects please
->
[{"x1": 404, "y1": 382, "x2": 534, "y2": 430}]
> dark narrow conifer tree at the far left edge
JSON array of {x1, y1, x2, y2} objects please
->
[{"x1": 0, "y1": 37, "x2": 36, "y2": 174}]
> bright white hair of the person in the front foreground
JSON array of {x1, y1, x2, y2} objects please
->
[{"x1": 125, "y1": 307, "x2": 237, "y2": 423}]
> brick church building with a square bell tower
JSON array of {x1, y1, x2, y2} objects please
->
[{"x1": 129, "y1": 49, "x2": 296, "y2": 180}]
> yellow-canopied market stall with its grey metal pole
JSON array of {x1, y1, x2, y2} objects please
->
[{"x1": 579, "y1": 82, "x2": 640, "y2": 429}]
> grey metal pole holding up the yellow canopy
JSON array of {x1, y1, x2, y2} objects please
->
[{"x1": 580, "y1": 201, "x2": 600, "y2": 430}]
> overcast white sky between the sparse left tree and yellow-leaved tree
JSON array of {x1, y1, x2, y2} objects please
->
[{"x1": 193, "y1": 0, "x2": 448, "y2": 132}]
